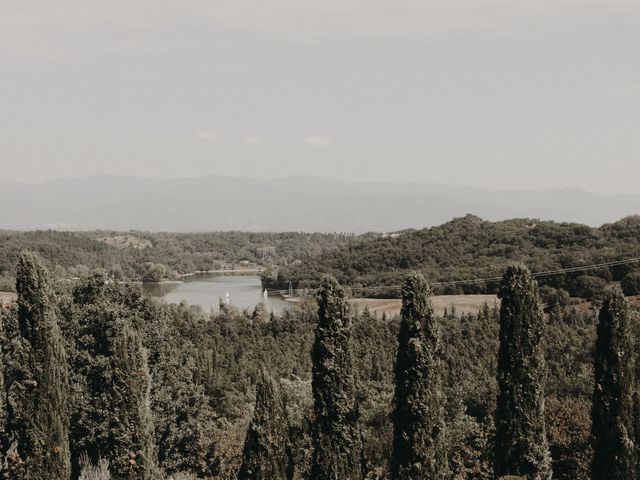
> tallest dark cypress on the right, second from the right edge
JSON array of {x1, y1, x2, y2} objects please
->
[{"x1": 494, "y1": 265, "x2": 551, "y2": 480}]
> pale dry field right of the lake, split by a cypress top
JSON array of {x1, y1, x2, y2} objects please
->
[{"x1": 351, "y1": 295, "x2": 499, "y2": 315}]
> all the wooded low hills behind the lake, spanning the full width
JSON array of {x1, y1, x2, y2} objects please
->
[{"x1": 5, "y1": 215, "x2": 640, "y2": 304}]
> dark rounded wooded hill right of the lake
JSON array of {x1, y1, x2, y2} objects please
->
[{"x1": 262, "y1": 215, "x2": 640, "y2": 301}]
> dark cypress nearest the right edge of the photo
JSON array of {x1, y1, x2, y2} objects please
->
[{"x1": 591, "y1": 291, "x2": 636, "y2": 480}]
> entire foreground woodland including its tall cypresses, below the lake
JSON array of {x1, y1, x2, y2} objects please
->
[{"x1": 0, "y1": 254, "x2": 640, "y2": 480}]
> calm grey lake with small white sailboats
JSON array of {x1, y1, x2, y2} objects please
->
[{"x1": 143, "y1": 273, "x2": 291, "y2": 313}]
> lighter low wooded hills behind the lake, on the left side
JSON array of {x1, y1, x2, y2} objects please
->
[{"x1": 0, "y1": 230, "x2": 353, "y2": 291}]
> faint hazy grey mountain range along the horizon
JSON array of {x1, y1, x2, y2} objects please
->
[{"x1": 0, "y1": 175, "x2": 640, "y2": 233}]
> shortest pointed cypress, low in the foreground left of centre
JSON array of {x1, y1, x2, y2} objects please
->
[{"x1": 238, "y1": 370, "x2": 287, "y2": 480}]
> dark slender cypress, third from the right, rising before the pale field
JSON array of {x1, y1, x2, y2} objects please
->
[{"x1": 391, "y1": 273, "x2": 447, "y2": 480}]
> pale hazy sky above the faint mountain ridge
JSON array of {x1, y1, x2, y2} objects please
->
[{"x1": 0, "y1": 0, "x2": 640, "y2": 193}]
